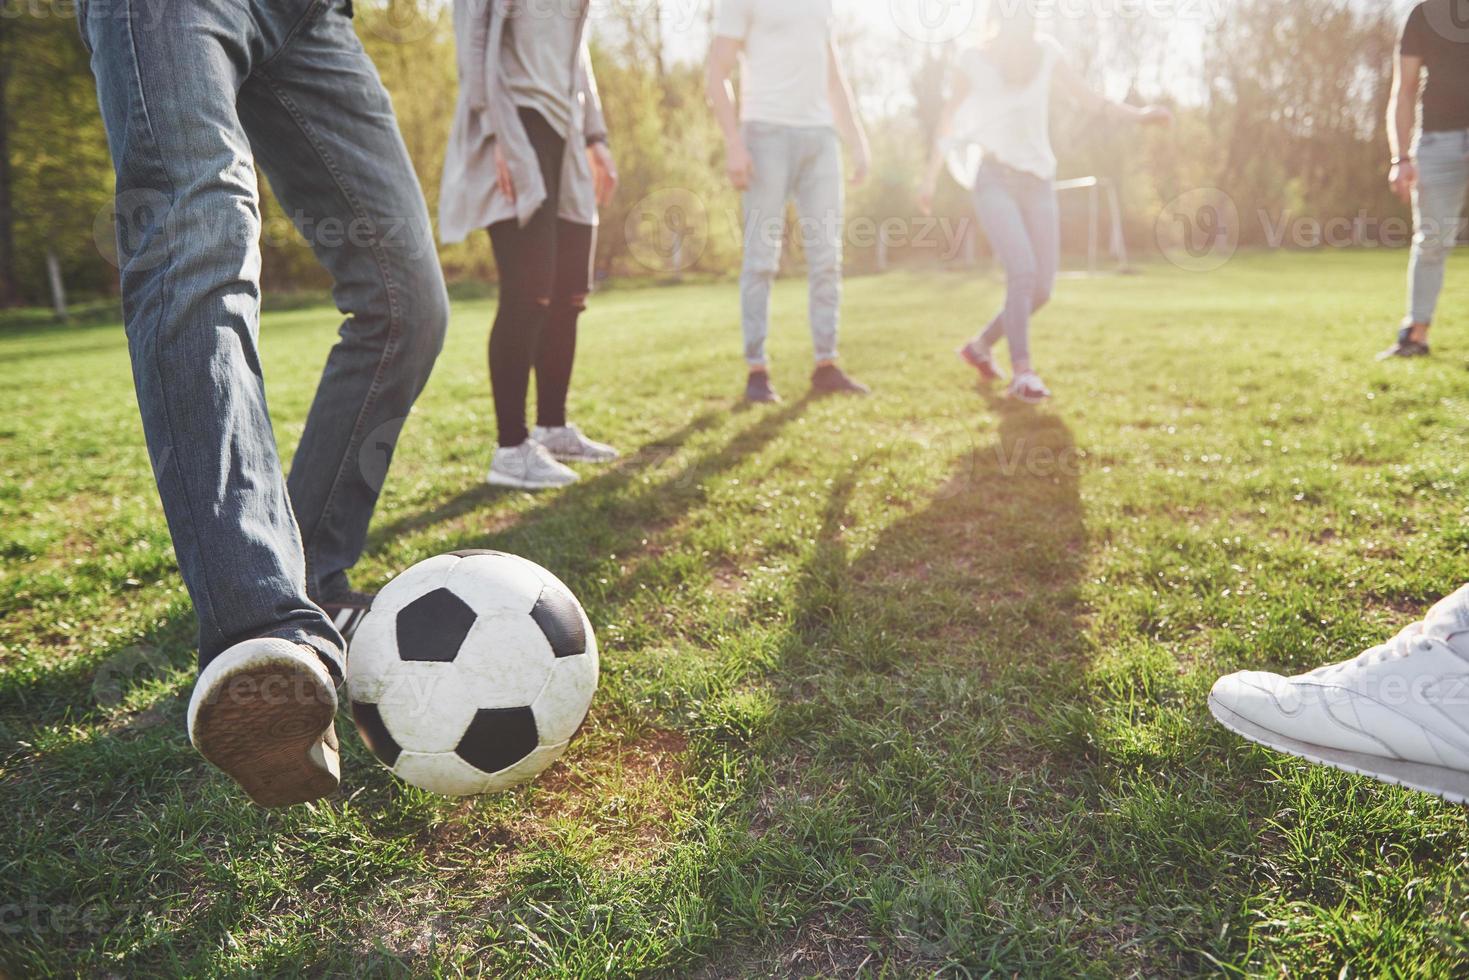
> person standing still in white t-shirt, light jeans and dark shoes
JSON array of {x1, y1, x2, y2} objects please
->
[{"x1": 708, "y1": 0, "x2": 870, "y2": 401}]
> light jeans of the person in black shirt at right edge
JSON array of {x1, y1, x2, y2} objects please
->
[{"x1": 1407, "y1": 129, "x2": 1469, "y2": 323}]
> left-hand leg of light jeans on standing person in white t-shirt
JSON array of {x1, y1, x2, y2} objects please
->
[{"x1": 739, "y1": 123, "x2": 792, "y2": 367}]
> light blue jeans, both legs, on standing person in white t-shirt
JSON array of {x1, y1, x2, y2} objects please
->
[{"x1": 740, "y1": 122, "x2": 846, "y2": 367}]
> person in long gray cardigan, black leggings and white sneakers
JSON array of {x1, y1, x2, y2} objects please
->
[{"x1": 439, "y1": 0, "x2": 617, "y2": 489}]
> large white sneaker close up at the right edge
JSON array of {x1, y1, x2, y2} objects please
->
[{"x1": 1209, "y1": 586, "x2": 1469, "y2": 804}]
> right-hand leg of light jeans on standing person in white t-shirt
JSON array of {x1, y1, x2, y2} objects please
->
[{"x1": 795, "y1": 129, "x2": 846, "y2": 361}]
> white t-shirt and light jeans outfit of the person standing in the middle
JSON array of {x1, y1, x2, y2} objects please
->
[{"x1": 714, "y1": 0, "x2": 845, "y2": 371}]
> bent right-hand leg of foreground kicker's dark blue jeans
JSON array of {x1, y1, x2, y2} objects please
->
[{"x1": 239, "y1": 0, "x2": 448, "y2": 599}]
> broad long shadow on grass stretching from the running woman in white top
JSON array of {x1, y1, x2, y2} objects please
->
[{"x1": 711, "y1": 393, "x2": 1094, "y2": 976}]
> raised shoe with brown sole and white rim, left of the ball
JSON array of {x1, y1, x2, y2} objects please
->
[{"x1": 188, "y1": 638, "x2": 341, "y2": 807}]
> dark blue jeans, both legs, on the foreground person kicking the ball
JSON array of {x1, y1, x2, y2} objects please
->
[{"x1": 78, "y1": 0, "x2": 448, "y2": 673}]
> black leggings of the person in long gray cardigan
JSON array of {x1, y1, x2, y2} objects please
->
[{"x1": 489, "y1": 109, "x2": 596, "y2": 445}]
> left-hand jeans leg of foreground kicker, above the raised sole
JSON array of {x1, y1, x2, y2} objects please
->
[{"x1": 82, "y1": 0, "x2": 342, "y2": 671}]
